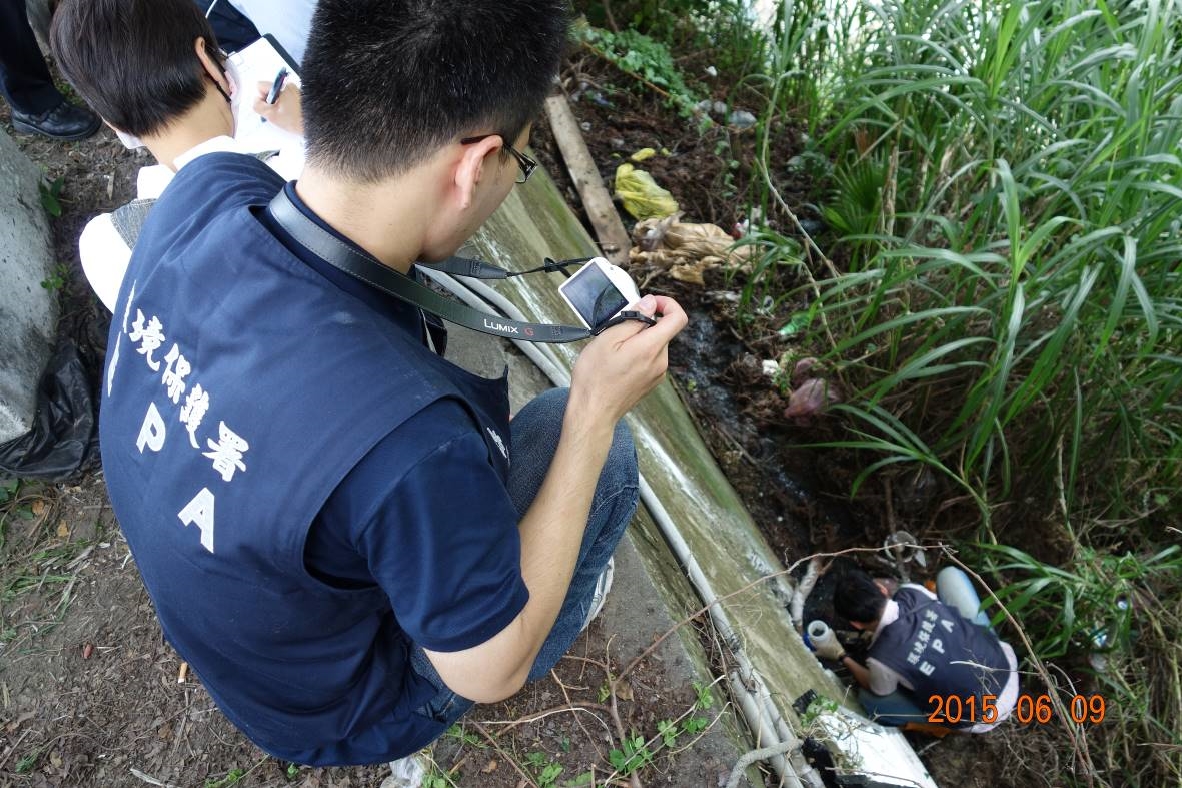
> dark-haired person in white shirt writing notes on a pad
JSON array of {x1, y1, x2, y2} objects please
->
[{"x1": 51, "y1": 0, "x2": 304, "y2": 310}]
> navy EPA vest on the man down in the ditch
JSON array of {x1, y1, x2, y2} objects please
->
[{"x1": 869, "y1": 587, "x2": 1009, "y2": 710}]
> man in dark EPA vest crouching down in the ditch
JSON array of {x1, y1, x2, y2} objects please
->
[{"x1": 818, "y1": 568, "x2": 1018, "y2": 734}]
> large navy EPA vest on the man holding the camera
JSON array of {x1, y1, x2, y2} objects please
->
[{"x1": 100, "y1": 155, "x2": 509, "y2": 763}]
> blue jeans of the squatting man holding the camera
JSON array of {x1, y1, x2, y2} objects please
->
[{"x1": 410, "y1": 389, "x2": 639, "y2": 725}]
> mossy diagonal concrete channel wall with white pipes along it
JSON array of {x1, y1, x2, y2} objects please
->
[{"x1": 416, "y1": 171, "x2": 935, "y2": 788}]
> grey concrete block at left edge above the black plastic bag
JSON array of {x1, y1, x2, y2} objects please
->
[{"x1": 0, "y1": 131, "x2": 58, "y2": 443}]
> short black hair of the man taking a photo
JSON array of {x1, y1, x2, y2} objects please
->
[{"x1": 300, "y1": 0, "x2": 570, "y2": 182}]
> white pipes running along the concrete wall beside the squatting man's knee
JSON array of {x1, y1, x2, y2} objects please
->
[{"x1": 420, "y1": 267, "x2": 819, "y2": 788}]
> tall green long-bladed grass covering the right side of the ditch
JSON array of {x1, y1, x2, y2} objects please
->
[{"x1": 728, "y1": 0, "x2": 1182, "y2": 784}]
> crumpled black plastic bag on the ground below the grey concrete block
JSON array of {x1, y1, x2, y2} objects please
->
[{"x1": 0, "y1": 339, "x2": 98, "y2": 482}]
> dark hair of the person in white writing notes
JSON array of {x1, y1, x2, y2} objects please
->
[{"x1": 50, "y1": 0, "x2": 220, "y2": 136}]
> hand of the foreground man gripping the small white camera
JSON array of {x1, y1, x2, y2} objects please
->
[{"x1": 567, "y1": 295, "x2": 689, "y2": 426}]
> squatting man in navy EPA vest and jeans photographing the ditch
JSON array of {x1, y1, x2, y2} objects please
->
[{"x1": 94, "y1": 0, "x2": 686, "y2": 764}]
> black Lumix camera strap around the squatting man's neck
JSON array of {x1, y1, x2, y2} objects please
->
[{"x1": 267, "y1": 189, "x2": 656, "y2": 343}]
